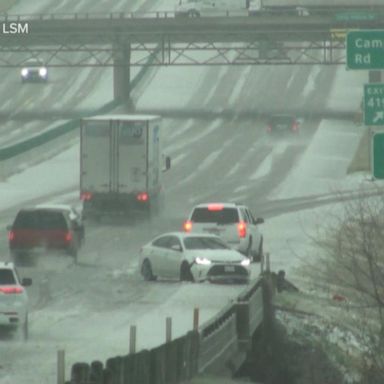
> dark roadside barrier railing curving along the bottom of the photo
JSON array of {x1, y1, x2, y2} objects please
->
[{"x1": 62, "y1": 274, "x2": 269, "y2": 384}]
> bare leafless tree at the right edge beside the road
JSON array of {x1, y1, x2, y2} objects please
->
[{"x1": 311, "y1": 190, "x2": 384, "y2": 384}]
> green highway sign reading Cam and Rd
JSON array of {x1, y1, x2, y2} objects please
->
[{"x1": 347, "y1": 30, "x2": 384, "y2": 69}]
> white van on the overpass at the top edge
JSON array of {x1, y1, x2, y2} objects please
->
[{"x1": 175, "y1": 0, "x2": 261, "y2": 17}]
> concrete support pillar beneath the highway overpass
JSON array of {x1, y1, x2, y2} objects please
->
[{"x1": 113, "y1": 41, "x2": 131, "y2": 101}]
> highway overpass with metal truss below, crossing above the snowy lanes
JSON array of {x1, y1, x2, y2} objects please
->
[{"x1": 0, "y1": 12, "x2": 383, "y2": 99}]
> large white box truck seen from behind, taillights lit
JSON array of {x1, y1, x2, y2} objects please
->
[{"x1": 80, "y1": 114, "x2": 170, "y2": 219}]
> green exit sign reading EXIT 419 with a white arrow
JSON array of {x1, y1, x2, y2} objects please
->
[{"x1": 364, "y1": 83, "x2": 384, "y2": 125}]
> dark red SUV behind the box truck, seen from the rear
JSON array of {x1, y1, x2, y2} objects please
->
[{"x1": 8, "y1": 207, "x2": 84, "y2": 262}]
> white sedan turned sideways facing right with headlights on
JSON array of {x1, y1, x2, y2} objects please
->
[{"x1": 140, "y1": 232, "x2": 250, "y2": 282}]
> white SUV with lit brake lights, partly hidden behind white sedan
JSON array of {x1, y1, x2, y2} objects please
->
[{"x1": 183, "y1": 203, "x2": 264, "y2": 261}]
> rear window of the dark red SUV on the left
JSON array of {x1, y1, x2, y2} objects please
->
[{"x1": 13, "y1": 210, "x2": 67, "y2": 229}]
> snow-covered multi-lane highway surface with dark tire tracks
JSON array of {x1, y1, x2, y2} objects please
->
[{"x1": 0, "y1": 0, "x2": 376, "y2": 384}]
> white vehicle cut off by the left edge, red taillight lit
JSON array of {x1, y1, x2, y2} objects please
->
[{"x1": 0, "y1": 262, "x2": 32, "y2": 339}]
